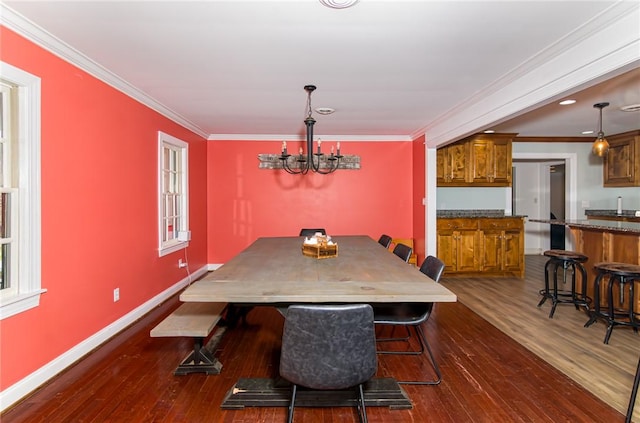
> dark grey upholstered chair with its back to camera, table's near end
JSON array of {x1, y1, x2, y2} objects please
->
[{"x1": 280, "y1": 304, "x2": 378, "y2": 423}]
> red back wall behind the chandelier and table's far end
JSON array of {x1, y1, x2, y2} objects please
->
[{"x1": 207, "y1": 141, "x2": 413, "y2": 263}]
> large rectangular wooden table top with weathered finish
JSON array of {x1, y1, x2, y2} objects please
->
[{"x1": 180, "y1": 236, "x2": 456, "y2": 304}]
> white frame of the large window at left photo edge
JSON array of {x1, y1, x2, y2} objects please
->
[{"x1": 0, "y1": 61, "x2": 46, "y2": 320}]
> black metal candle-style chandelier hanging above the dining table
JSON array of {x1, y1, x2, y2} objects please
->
[{"x1": 278, "y1": 85, "x2": 343, "y2": 175}]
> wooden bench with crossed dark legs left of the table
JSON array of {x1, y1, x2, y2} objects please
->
[{"x1": 150, "y1": 303, "x2": 227, "y2": 375}]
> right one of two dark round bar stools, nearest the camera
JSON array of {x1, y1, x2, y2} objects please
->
[{"x1": 584, "y1": 262, "x2": 640, "y2": 344}]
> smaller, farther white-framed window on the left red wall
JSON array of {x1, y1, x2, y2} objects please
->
[{"x1": 158, "y1": 132, "x2": 190, "y2": 256}]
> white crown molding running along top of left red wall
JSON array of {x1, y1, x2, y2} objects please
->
[{"x1": 0, "y1": 2, "x2": 208, "y2": 138}]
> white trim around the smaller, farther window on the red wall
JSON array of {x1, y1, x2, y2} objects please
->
[{"x1": 158, "y1": 131, "x2": 189, "y2": 257}]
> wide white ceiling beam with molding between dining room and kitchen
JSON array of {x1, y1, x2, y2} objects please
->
[{"x1": 420, "y1": 1, "x2": 640, "y2": 148}]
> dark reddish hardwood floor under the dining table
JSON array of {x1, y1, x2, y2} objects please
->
[{"x1": 0, "y1": 264, "x2": 624, "y2": 423}]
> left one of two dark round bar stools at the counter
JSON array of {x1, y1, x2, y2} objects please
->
[{"x1": 538, "y1": 250, "x2": 591, "y2": 319}]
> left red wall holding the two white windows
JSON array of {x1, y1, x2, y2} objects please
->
[{"x1": 0, "y1": 27, "x2": 207, "y2": 390}]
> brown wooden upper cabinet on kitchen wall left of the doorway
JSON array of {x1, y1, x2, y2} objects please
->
[{"x1": 437, "y1": 134, "x2": 516, "y2": 187}]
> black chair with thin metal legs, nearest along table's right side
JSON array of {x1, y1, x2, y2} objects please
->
[{"x1": 373, "y1": 256, "x2": 445, "y2": 385}]
